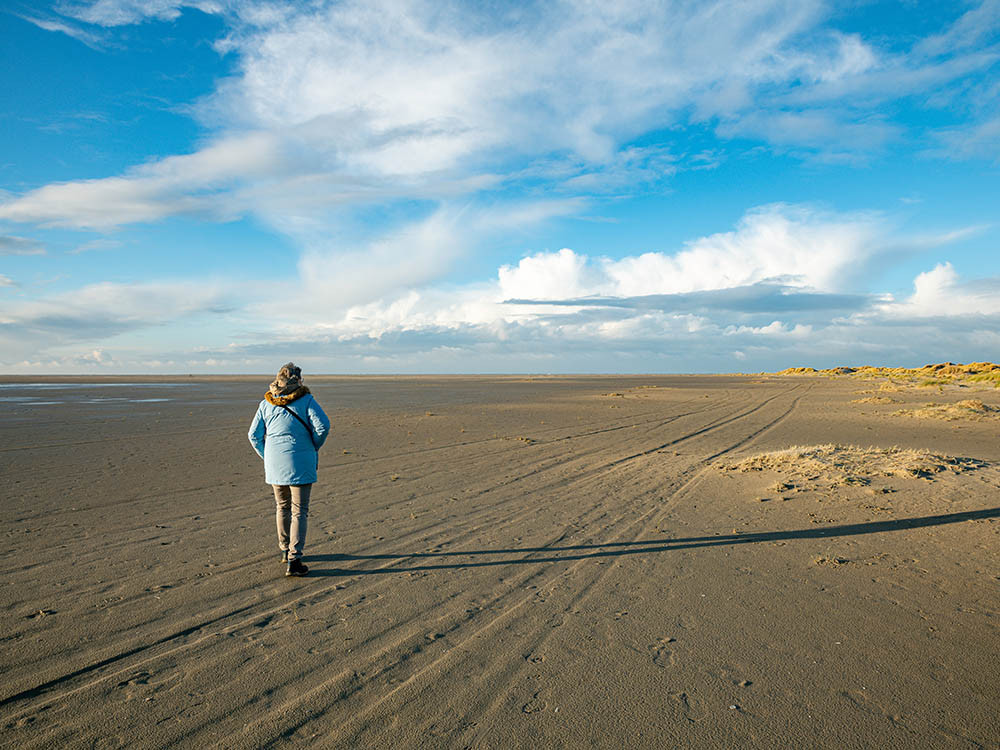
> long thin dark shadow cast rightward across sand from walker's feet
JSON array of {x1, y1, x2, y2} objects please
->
[{"x1": 309, "y1": 508, "x2": 1000, "y2": 576}]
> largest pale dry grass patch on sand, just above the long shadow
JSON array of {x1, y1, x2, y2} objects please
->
[{"x1": 725, "y1": 443, "x2": 986, "y2": 485}]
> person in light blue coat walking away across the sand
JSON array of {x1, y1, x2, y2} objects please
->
[{"x1": 247, "y1": 362, "x2": 330, "y2": 576}]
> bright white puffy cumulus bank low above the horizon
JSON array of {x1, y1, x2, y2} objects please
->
[{"x1": 225, "y1": 205, "x2": 984, "y2": 371}]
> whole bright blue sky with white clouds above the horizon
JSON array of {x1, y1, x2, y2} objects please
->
[{"x1": 0, "y1": 0, "x2": 1000, "y2": 375}]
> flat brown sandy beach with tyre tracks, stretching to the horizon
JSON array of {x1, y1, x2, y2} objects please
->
[{"x1": 0, "y1": 375, "x2": 1000, "y2": 748}]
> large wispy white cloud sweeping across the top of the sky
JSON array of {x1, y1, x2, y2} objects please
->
[{"x1": 0, "y1": 0, "x2": 932, "y2": 234}]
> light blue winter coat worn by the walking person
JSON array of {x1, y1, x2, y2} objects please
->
[{"x1": 247, "y1": 394, "x2": 330, "y2": 484}]
